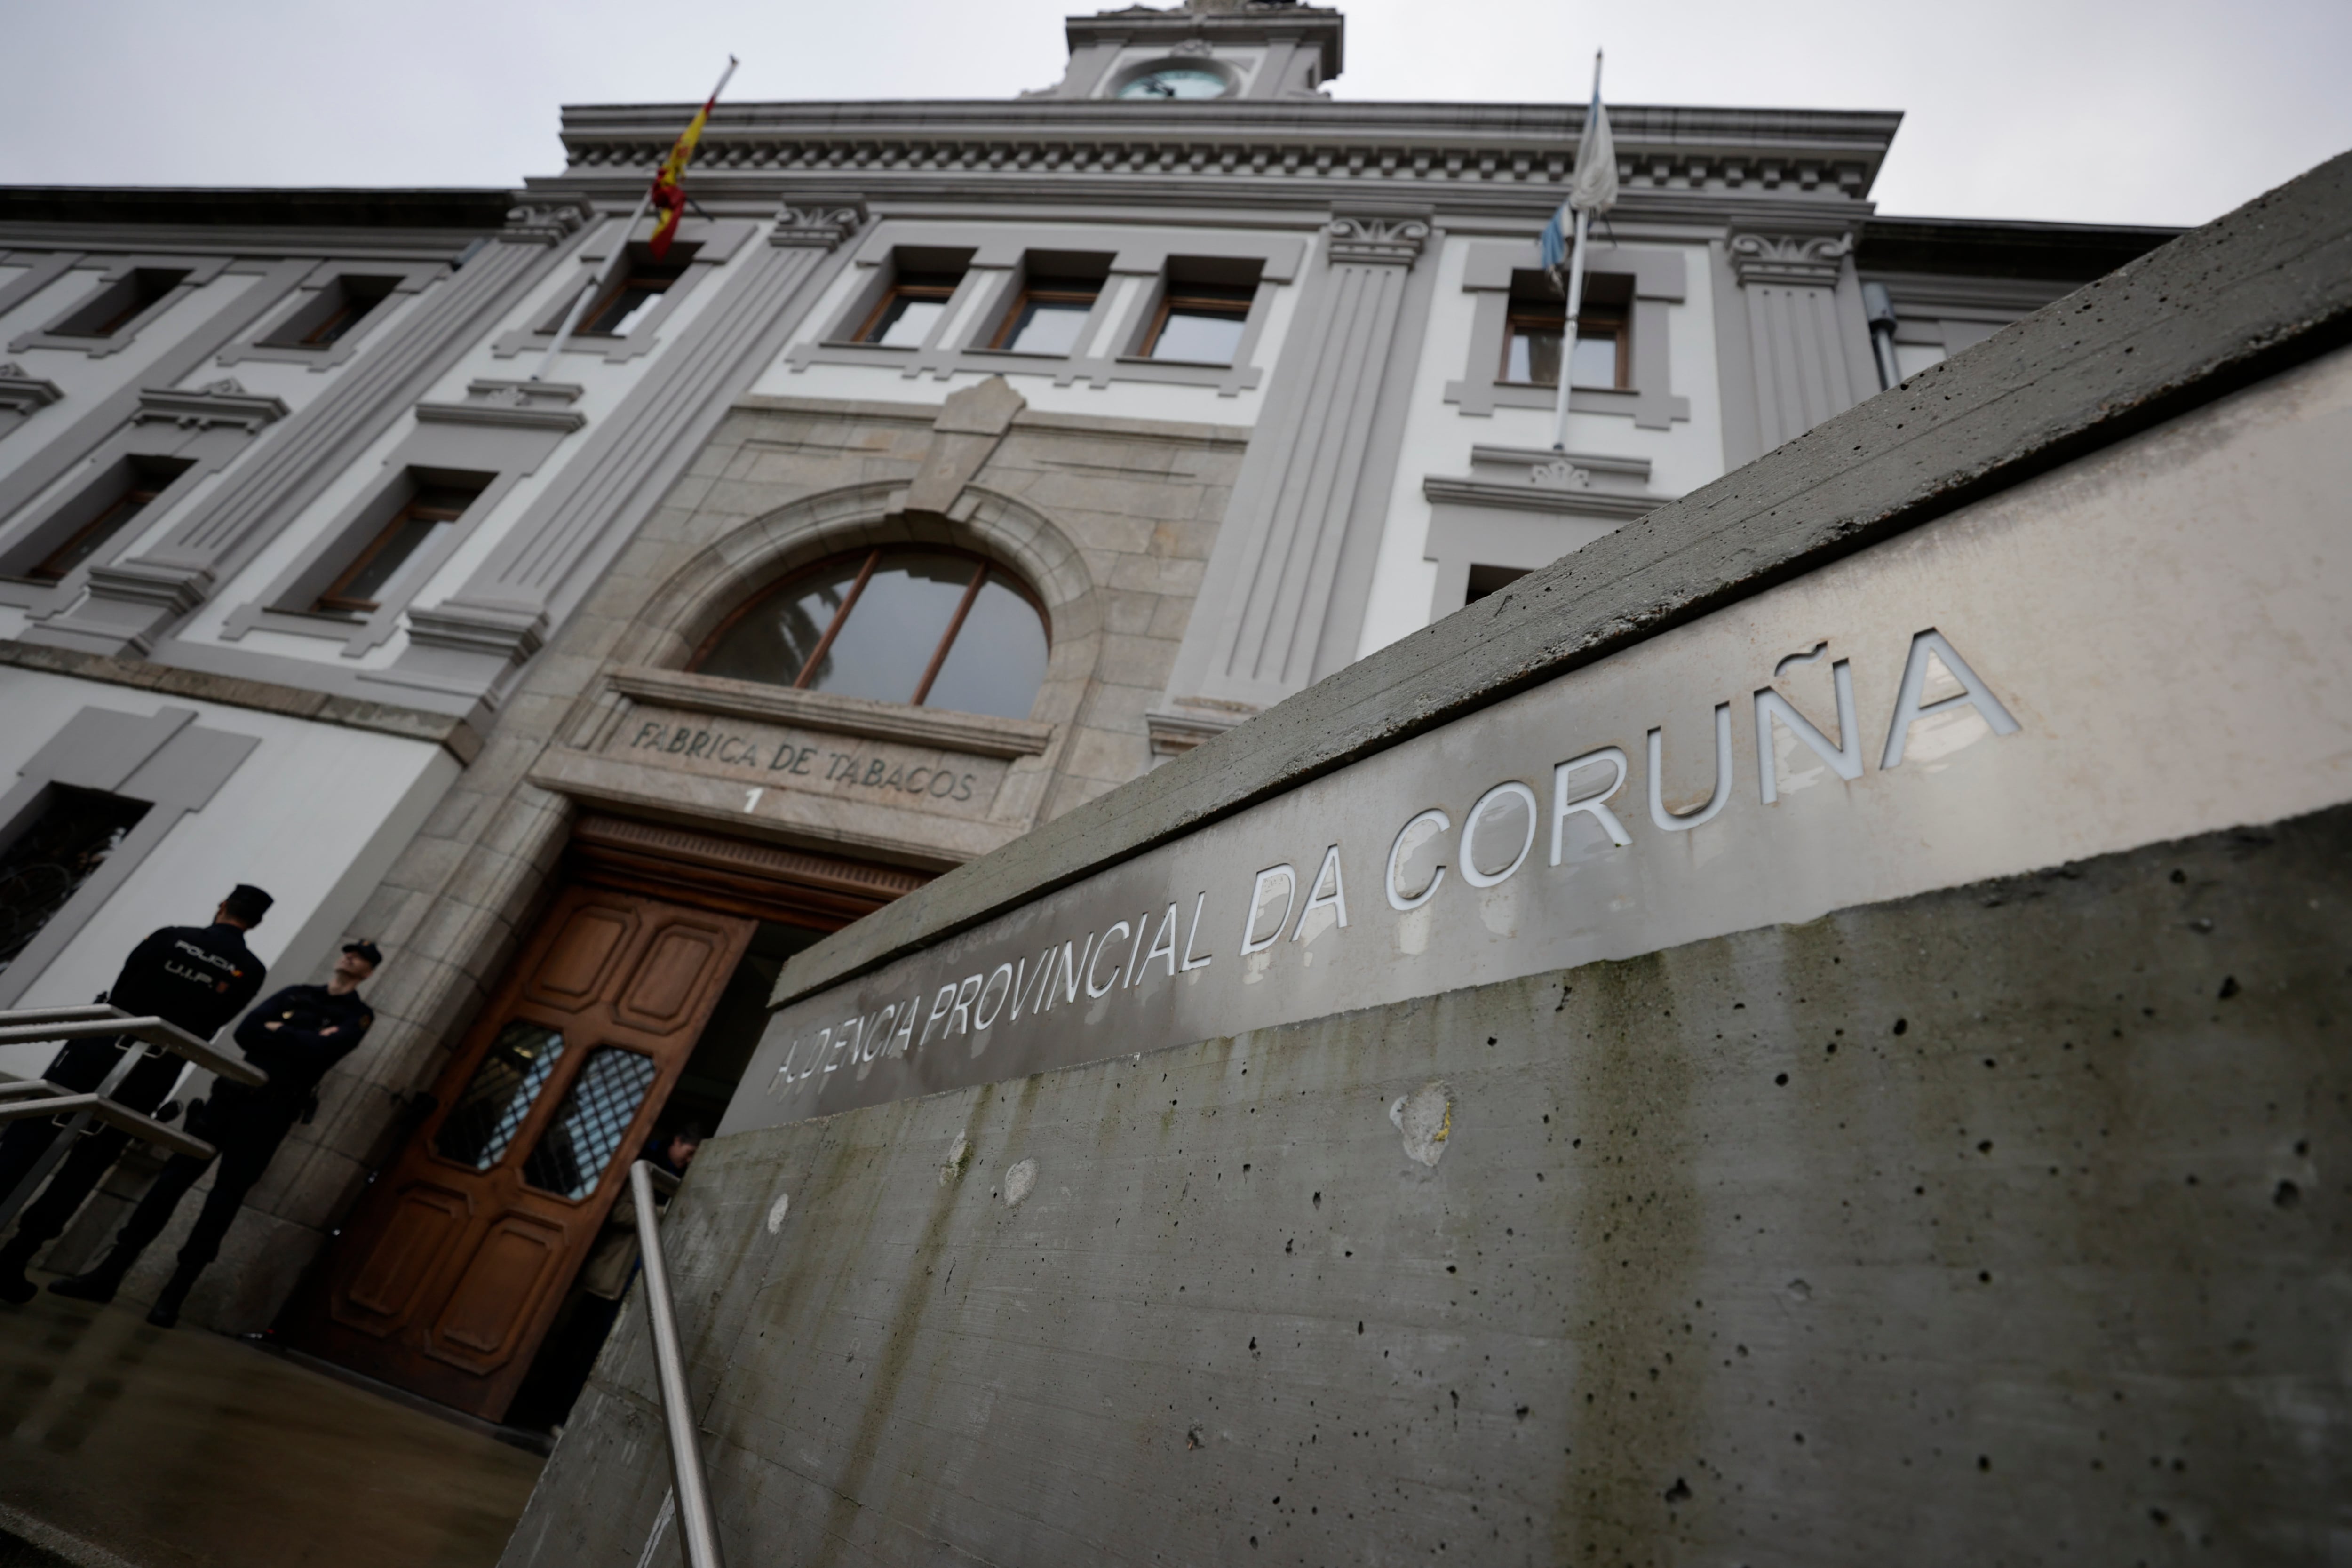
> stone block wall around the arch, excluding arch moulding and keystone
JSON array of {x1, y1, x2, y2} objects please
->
[{"x1": 140, "y1": 385, "x2": 1247, "y2": 1330}]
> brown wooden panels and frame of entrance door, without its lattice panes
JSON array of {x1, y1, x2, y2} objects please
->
[{"x1": 289, "y1": 884, "x2": 755, "y2": 1420}]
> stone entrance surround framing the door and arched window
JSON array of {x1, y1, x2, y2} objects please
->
[{"x1": 154, "y1": 379, "x2": 1249, "y2": 1330}]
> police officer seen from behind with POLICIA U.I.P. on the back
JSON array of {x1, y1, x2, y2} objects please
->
[{"x1": 0, "y1": 884, "x2": 275, "y2": 1307}]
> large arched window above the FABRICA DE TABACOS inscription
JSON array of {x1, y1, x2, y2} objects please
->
[{"x1": 694, "y1": 548, "x2": 1047, "y2": 719}]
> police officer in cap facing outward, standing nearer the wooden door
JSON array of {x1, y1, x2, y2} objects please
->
[{"x1": 49, "y1": 943, "x2": 383, "y2": 1328}]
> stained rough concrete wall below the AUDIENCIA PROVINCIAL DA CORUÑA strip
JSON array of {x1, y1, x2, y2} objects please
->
[{"x1": 503, "y1": 809, "x2": 2352, "y2": 1568}]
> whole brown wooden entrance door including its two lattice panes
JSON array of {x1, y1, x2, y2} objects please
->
[{"x1": 287, "y1": 886, "x2": 757, "y2": 1420}]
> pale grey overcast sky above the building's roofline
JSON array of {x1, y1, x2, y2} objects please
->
[{"x1": 0, "y1": 0, "x2": 2352, "y2": 223}]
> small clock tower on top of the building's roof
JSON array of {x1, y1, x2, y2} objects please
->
[{"x1": 1028, "y1": 0, "x2": 1345, "y2": 103}]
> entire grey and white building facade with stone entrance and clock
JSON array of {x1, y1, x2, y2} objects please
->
[{"x1": 0, "y1": 2, "x2": 2169, "y2": 1420}]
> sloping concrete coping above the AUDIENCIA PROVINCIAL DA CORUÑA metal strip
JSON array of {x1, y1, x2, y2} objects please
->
[{"x1": 776, "y1": 153, "x2": 2352, "y2": 1002}]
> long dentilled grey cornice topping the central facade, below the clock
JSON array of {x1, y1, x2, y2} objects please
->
[{"x1": 548, "y1": 99, "x2": 1900, "y2": 207}]
